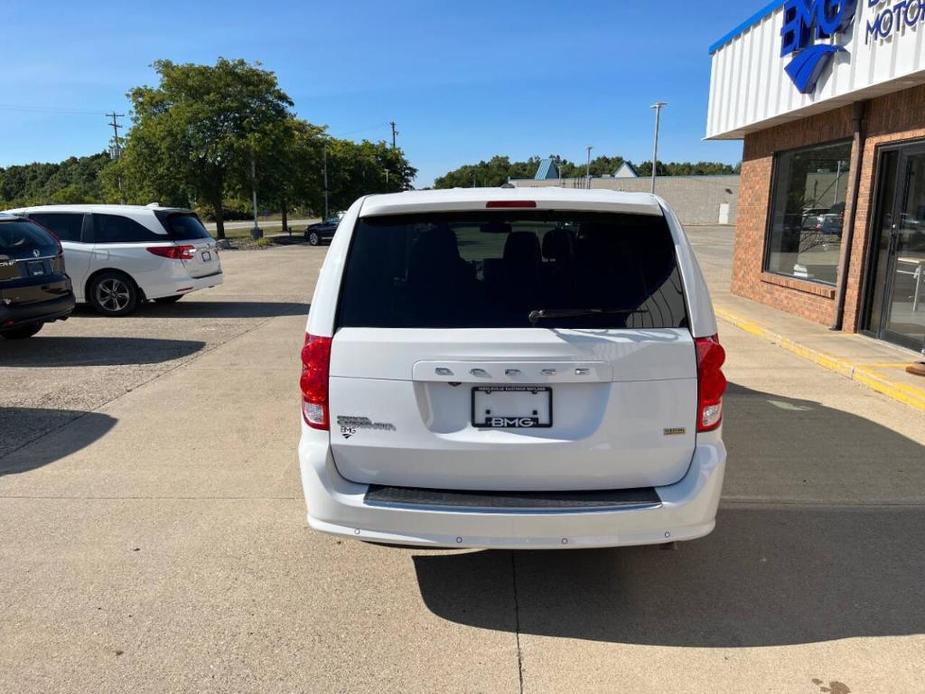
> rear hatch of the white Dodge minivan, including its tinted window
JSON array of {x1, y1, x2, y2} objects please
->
[{"x1": 330, "y1": 206, "x2": 697, "y2": 491}]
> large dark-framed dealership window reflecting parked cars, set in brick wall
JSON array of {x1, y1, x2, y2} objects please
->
[{"x1": 765, "y1": 142, "x2": 851, "y2": 284}]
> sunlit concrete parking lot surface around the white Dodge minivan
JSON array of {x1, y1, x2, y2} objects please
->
[{"x1": 0, "y1": 235, "x2": 925, "y2": 694}]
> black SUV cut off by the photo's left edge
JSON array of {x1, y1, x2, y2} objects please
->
[{"x1": 0, "y1": 213, "x2": 74, "y2": 340}]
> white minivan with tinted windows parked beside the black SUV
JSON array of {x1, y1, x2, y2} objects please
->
[{"x1": 8, "y1": 205, "x2": 223, "y2": 316}]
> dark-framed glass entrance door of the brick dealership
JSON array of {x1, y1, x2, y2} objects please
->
[{"x1": 868, "y1": 145, "x2": 925, "y2": 350}]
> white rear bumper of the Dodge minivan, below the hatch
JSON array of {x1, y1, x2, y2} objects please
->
[{"x1": 299, "y1": 432, "x2": 726, "y2": 549}]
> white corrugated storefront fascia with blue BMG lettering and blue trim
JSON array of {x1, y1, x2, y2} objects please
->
[{"x1": 707, "y1": 0, "x2": 925, "y2": 139}]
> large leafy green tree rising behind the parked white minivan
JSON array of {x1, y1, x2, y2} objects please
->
[{"x1": 118, "y1": 58, "x2": 292, "y2": 238}]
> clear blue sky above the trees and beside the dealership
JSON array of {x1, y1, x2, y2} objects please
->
[{"x1": 0, "y1": 0, "x2": 761, "y2": 186}]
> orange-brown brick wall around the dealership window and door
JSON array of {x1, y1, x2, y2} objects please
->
[{"x1": 732, "y1": 86, "x2": 925, "y2": 331}]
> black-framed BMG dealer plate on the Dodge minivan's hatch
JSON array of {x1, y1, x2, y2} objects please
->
[{"x1": 472, "y1": 386, "x2": 552, "y2": 429}]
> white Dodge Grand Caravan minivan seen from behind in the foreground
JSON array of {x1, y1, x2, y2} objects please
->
[{"x1": 299, "y1": 188, "x2": 726, "y2": 548}]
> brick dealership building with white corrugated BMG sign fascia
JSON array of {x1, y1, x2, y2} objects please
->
[{"x1": 707, "y1": 0, "x2": 925, "y2": 350}]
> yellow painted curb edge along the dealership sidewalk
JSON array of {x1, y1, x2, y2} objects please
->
[{"x1": 714, "y1": 306, "x2": 925, "y2": 412}]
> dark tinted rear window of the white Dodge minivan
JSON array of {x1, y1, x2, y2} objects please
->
[{"x1": 337, "y1": 211, "x2": 687, "y2": 329}]
